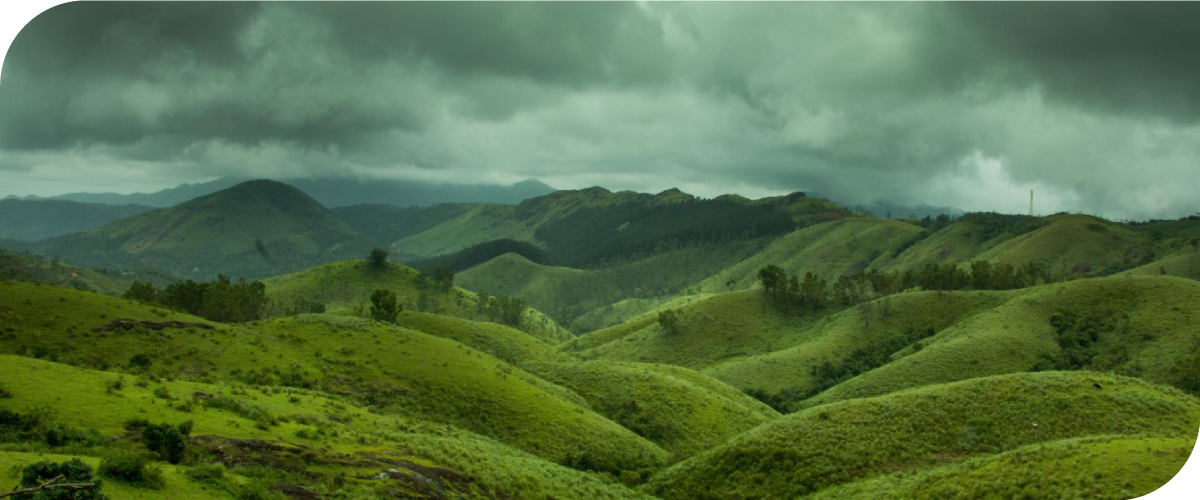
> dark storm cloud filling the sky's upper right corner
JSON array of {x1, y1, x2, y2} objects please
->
[{"x1": 930, "y1": 0, "x2": 1200, "y2": 121}]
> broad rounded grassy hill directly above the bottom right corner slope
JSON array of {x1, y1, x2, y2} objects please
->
[{"x1": 646, "y1": 372, "x2": 1200, "y2": 499}]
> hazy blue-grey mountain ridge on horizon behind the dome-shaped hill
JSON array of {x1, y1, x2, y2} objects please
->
[{"x1": 23, "y1": 177, "x2": 554, "y2": 207}]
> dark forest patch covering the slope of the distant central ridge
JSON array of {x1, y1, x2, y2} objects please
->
[{"x1": 534, "y1": 199, "x2": 796, "y2": 267}]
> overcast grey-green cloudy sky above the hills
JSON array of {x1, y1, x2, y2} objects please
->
[{"x1": 0, "y1": 0, "x2": 1200, "y2": 219}]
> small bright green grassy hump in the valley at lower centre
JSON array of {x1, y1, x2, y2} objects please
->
[{"x1": 539, "y1": 361, "x2": 779, "y2": 459}]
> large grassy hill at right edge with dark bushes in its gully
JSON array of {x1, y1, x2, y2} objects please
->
[{"x1": 804, "y1": 277, "x2": 1200, "y2": 405}]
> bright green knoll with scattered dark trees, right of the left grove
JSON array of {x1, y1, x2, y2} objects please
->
[{"x1": 263, "y1": 259, "x2": 574, "y2": 343}]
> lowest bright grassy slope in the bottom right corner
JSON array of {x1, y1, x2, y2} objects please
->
[{"x1": 810, "y1": 436, "x2": 1196, "y2": 500}]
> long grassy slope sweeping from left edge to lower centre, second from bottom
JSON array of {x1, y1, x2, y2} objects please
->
[{"x1": 0, "y1": 283, "x2": 666, "y2": 470}]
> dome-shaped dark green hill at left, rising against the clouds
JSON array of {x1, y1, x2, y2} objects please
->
[{"x1": 35, "y1": 181, "x2": 373, "y2": 278}]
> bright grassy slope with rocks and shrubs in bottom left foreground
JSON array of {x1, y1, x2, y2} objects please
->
[{"x1": 0, "y1": 356, "x2": 657, "y2": 499}]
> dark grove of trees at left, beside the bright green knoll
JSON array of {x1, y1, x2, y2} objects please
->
[{"x1": 125, "y1": 276, "x2": 269, "y2": 323}]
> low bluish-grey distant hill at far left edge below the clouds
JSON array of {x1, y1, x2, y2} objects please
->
[{"x1": 0, "y1": 199, "x2": 151, "y2": 241}]
